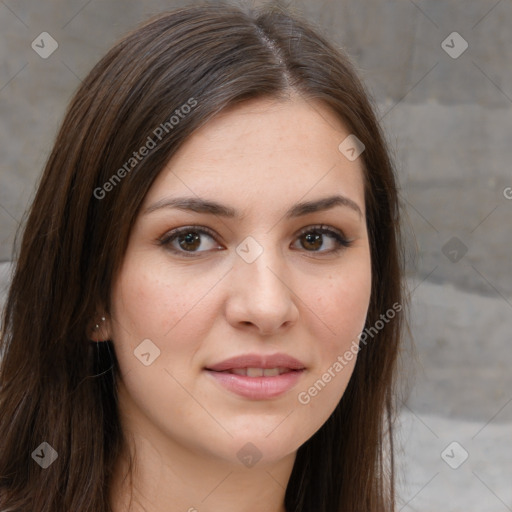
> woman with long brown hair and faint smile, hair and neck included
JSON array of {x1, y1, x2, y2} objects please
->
[{"x1": 0, "y1": 4, "x2": 403, "y2": 512}]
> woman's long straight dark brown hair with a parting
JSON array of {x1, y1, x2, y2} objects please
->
[{"x1": 0, "y1": 3, "x2": 403, "y2": 512}]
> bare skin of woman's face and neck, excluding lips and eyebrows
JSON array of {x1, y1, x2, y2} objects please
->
[{"x1": 101, "y1": 96, "x2": 371, "y2": 512}]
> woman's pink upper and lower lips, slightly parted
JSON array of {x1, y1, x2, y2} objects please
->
[{"x1": 204, "y1": 354, "x2": 306, "y2": 400}]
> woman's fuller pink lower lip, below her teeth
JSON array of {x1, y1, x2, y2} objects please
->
[{"x1": 205, "y1": 370, "x2": 304, "y2": 400}]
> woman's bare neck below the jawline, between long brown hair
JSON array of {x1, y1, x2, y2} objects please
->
[{"x1": 110, "y1": 388, "x2": 296, "y2": 512}]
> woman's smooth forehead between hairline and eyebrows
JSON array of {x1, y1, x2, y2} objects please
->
[{"x1": 145, "y1": 97, "x2": 364, "y2": 211}]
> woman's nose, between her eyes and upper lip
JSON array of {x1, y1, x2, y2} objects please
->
[{"x1": 226, "y1": 239, "x2": 299, "y2": 336}]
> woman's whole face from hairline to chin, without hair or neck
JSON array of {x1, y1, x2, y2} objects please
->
[{"x1": 108, "y1": 95, "x2": 371, "y2": 465}]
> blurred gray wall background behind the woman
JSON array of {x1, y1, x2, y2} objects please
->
[{"x1": 0, "y1": 0, "x2": 512, "y2": 512}]
